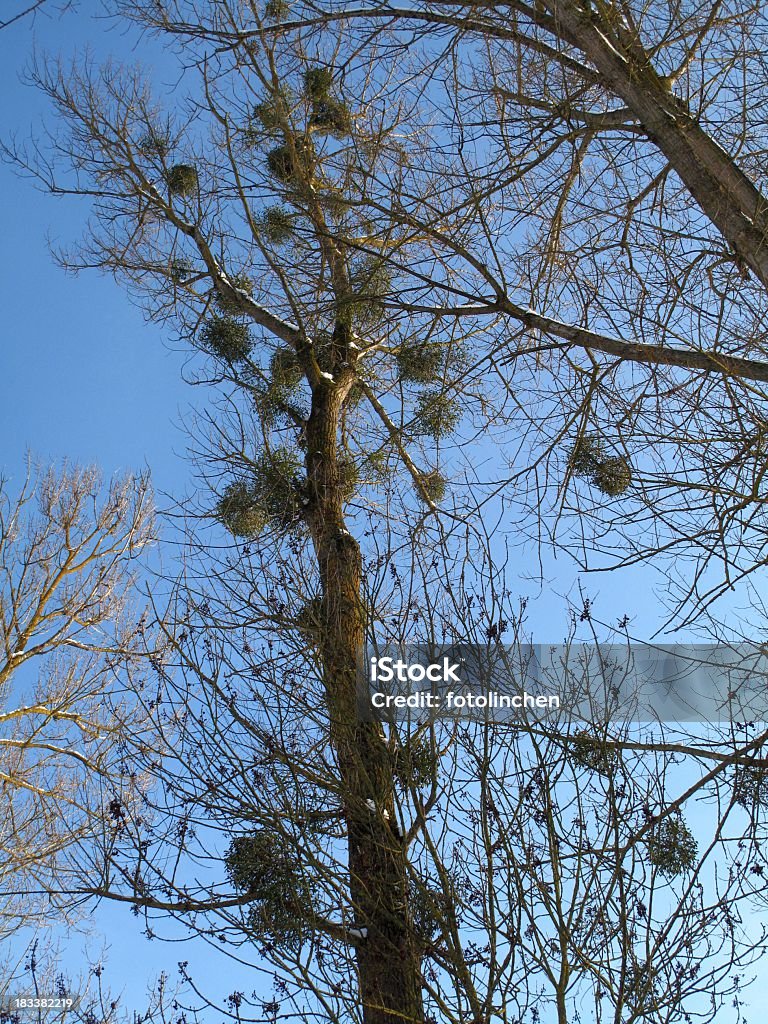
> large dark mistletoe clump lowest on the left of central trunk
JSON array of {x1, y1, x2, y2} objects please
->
[{"x1": 224, "y1": 828, "x2": 312, "y2": 950}]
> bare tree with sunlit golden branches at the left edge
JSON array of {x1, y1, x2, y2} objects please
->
[{"x1": 0, "y1": 467, "x2": 153, "y2": 934}]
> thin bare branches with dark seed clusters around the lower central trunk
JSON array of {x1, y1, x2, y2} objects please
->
[{"x1": 93, "y1": 537, "x2": 766, "y2": 1024}]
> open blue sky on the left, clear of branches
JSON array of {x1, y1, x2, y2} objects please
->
[{"x1": 0, "y1": 6, "x2": 241, "y2": 1011}]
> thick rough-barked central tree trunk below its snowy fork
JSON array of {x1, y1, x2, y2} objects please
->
[{"x1": 306, "y1": 380, "x2": 423, "y2": 1024}]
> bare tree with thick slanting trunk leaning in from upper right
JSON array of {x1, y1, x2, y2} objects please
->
[{"x1": 93, "y1": 3, "x2": 767, "y2": 614}]
